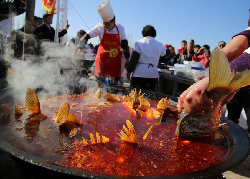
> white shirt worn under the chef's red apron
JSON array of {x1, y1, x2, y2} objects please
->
[{"x1": 87, "y1": 23, "x2": 126, "y2": 43}]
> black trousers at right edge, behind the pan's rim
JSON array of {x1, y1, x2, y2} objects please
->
[{"x1": 227, "y1": 89, "x2": 250, "y2": 132}]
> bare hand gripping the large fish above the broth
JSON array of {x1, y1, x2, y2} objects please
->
[{"x1": 178, "y1": 77, "x2": 213, "y2": 116}]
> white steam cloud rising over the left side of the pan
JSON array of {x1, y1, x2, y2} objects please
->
[{"x1": 8, "y1": 39, "x2": 97, "y2": 103}]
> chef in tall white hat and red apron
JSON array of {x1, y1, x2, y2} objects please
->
[{"x1": 77, "y1": 0, "x2": 130, "y2": 85}]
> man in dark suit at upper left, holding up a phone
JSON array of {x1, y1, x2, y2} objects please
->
[{"x1": 35, "y1": 14, "x2": 69, "y2": 42}]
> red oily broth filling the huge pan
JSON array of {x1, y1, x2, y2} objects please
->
[{"x1": 1, "y1": 95, "x2": 229, "y2": 176}]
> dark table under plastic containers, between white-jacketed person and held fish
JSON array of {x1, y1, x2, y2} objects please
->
[{"x1": 158, "y1": 69, "x2": 196, "y2": 97}]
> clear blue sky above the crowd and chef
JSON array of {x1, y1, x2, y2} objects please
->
[{"x1": 32, "y1": 0, "x2": 250, "y2": 50}]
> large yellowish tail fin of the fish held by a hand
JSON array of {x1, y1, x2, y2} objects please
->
[{"x1": 207, "y1": 48, "x2": 250, "y2": 91}]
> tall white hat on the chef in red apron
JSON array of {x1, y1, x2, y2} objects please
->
[{"x1": 97, "y1": 0, "x2": 115, "y2": 22}]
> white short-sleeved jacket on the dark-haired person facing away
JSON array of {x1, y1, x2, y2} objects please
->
[{"x1": 132, "y1": 37, "x2": 166, "y2": 78}]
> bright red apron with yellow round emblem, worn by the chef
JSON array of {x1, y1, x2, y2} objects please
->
[{"x1": 95, "y1": 26, "x2": 121, "y2": 77}]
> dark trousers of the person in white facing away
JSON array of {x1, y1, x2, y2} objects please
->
[{"x1": 130, "y1": 77, "x2": 158, "y2": 92}]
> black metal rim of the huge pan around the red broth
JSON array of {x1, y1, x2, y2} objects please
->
[{"x1": 0, "y1": 87, "x2": 250, "y2": 179}]
